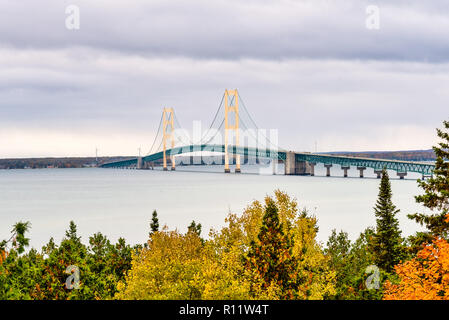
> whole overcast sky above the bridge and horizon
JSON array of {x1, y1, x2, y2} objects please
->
[{"x1": 0, "y1": 0, "x2": 449, "y2": 158}]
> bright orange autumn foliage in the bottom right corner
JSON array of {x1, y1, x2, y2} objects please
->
[{"x1": 384, "y1": 217, "x2": 449, "y2": 300}]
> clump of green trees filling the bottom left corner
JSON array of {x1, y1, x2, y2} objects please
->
[{"x1": 0, "y1": 221, "x2": 133, "y2": 300}]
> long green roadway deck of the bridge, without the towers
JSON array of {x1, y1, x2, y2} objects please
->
[{"x1": 100, "y1": 144, "x2": 435, "y2": 179}]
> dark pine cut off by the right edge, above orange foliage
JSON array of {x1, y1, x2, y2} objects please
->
[{"x1": 408, "y1": 121, "x2": 449, "y2": 248}]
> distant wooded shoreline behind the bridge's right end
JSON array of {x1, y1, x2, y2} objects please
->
[{"x1": 329, "y1": 149, "x2": 436, "y2": 161}]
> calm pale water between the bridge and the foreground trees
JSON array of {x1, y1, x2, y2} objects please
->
[{"x1": 0, "y1": 162, "x2": 428, "y2": 248}]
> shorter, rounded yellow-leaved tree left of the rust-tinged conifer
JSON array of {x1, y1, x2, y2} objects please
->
[{"x1": 116, "y1": 228, "x2": 249, "y2": 300}]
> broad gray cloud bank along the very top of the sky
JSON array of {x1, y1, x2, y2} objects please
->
[{"x1": 0, "y1": 0, "x2": 449, "y2": 62}]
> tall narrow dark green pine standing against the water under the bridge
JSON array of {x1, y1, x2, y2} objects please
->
[{"x1": 370, "y1": 168, "x2": 404, "y2": 272}]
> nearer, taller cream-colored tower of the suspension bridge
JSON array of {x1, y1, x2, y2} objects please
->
[{"x1": 224, "y1": 89, "x2": 241, "y2": 173}]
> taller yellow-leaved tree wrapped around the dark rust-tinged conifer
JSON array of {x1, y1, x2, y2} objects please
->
[{"x1": 214, "y1": 190, "x2": 335, "y2": 299}]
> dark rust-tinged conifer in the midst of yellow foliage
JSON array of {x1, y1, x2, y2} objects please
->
[{"x1": 246, "y1": 199, "x2": 298, "y2": 299}]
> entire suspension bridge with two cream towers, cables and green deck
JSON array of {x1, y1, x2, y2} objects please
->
[{"x1": 100, "y1": 90, "x2": 435, "y2": 179}]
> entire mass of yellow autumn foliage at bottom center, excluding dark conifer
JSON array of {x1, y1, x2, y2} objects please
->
[{"x1": 115, "y1": 191, "x2": 335, "y2": 299}]
